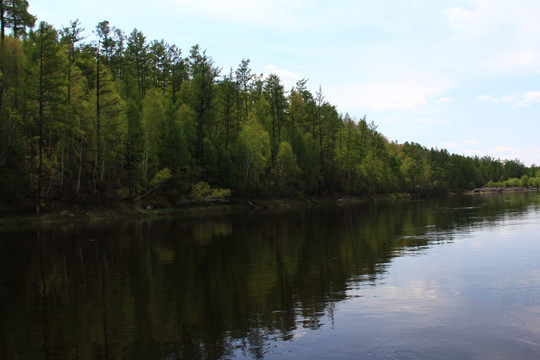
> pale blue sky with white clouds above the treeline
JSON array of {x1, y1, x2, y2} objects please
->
[{"x1": 29, "y1": 0, "x2": 540, "y2": 166}]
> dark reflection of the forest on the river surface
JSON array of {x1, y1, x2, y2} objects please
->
[{"x1": 0, "y1": 195, "x2": 538, "y2": 359}]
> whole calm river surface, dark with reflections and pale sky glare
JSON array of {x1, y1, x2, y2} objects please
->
[{"x1": 0, "y1": 194, "x2": 540, "y2": 359}]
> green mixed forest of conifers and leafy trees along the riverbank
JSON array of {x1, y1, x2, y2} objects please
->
[{"x1": 0, "y1": 0, "x2": 540, "y2": 213}]
